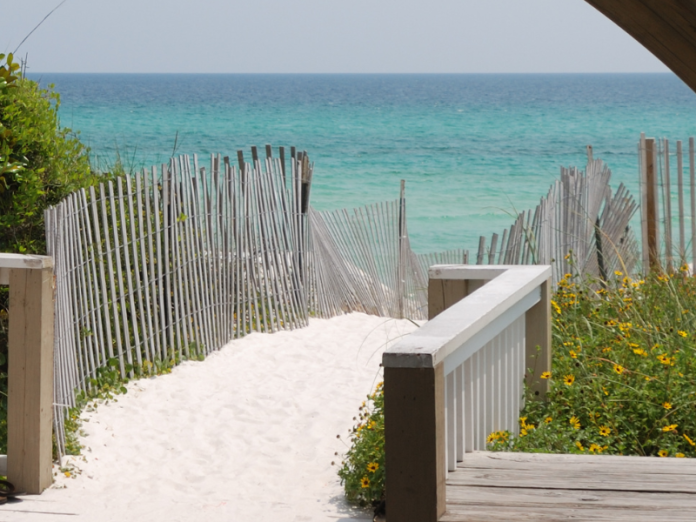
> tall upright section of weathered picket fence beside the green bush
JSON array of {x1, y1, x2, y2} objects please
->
[{"x1": 46, "y1": 145, "x2": 312, "y2": 451}]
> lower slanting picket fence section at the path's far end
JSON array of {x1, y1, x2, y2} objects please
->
[{"x1": 310, "y1": 181, "x2": 427, "y2": 319}]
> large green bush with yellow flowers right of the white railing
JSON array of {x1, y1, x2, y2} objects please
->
[{"x1": 488, "y1": 267, "x2": 696, "y2": 457}]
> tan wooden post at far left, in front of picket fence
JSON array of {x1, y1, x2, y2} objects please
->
[{"x1": 7, "y1": 256, "x2": 54, "y2": 494}]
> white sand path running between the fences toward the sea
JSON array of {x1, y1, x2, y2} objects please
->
[{"x1": 5, "y1": 314, "x2": 415, "y2": 522}]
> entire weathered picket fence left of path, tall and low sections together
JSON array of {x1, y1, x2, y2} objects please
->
[{"x1": 45, "y1": 146, "x2": 436, "y2": 453}]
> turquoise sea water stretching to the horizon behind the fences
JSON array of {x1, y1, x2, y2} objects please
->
[{"x1": 30, "y1": 74, "x2": 696, "y2": 252}]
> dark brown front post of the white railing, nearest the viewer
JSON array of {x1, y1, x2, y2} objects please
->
[{"x1": 384, "y1": 363, "x2": 446, "y2": 522}]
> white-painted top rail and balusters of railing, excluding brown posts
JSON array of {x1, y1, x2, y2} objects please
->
[{"x1": 383, "y1": 265, "x2": 551, "y2": 471}]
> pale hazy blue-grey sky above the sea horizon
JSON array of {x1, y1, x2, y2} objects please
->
[{"x1": 0, "y1": 0, "x2": 667, "y2": 73}]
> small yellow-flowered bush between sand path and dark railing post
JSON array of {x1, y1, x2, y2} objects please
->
[{"x1": 338, "y1": 382, "x2": 384, "y2": 506}]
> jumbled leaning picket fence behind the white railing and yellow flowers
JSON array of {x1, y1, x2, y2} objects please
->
[{"x1": 463, "y1": 154, "x2": 640, "y2": 282}]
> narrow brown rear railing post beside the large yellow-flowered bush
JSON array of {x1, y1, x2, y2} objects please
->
[{"x1": 525, "y1": 278, "x2": 552, "y2": 400}]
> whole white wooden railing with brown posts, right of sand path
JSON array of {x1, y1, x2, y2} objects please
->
[{"x1": 383, "y1": 265, "x2": 551, "y2": 522}]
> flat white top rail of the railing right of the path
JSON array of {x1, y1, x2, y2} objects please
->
[{"x1": 382, "y1": 265, "x2": 551, "y2": 368}]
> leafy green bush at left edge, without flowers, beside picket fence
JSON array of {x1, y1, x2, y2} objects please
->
[{"x1": 0, "y1": 54, "x2": 108, "y2": 453}]
